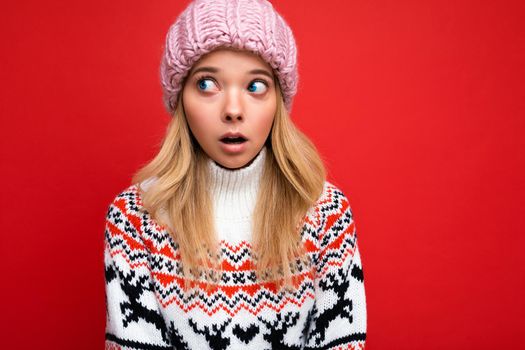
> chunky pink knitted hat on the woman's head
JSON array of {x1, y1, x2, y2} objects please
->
[{"x1": 160, "y1": 0, "x2": 299, "y2": 115}]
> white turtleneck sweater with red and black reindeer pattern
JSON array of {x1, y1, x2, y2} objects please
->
[{"x1": 104, "y1": 148, "x2": 366, "y2": 350}]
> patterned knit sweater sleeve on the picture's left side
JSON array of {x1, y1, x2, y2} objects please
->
[{"x1": 104, "y1": 192, "x2": 172, "y2": 350}]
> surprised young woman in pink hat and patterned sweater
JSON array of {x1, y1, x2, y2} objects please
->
[{"x1": 105, "y1": 0, "x2": 366, "y2": 349}]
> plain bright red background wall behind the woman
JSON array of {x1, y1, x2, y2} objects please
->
[{"x1": 0, "y1": 0, "x2": 525, "y2": 349}]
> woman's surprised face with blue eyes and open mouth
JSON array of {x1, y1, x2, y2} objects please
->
[{"x1": 182, "y1": 48, "x2": 277, "y2": 169}]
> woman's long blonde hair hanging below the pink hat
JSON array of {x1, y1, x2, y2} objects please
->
[{"x1": 132, "y1": 81, "x2": 326, "y2": 289}]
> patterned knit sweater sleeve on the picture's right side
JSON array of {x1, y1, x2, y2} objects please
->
[{"x1": 305, "y1": 187, "x2": 367, "y2": 350}]
